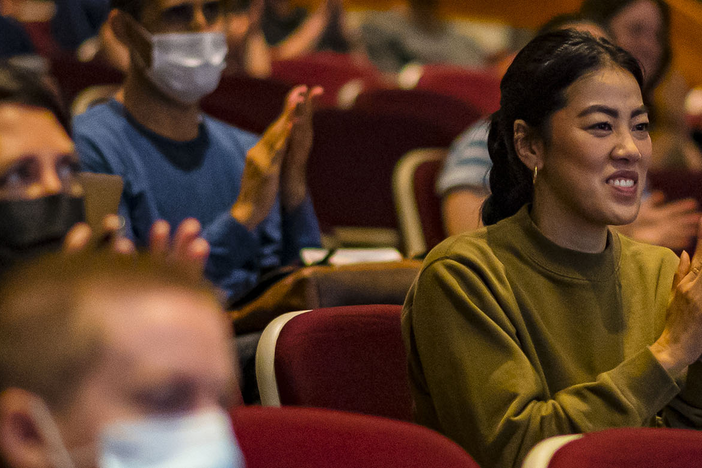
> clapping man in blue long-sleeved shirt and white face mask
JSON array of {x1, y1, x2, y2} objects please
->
[{"x1": 74, "y1": 0, "x2": 321, "y2": 300}]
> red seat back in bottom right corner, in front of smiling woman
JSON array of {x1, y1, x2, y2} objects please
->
[{"x1": 548, "y1": 428, "x2": 702, "y2": 468}]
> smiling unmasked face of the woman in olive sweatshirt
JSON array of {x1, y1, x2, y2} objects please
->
[{"x1": 534, "y1": 66, "x2": 651, "y2": 241}]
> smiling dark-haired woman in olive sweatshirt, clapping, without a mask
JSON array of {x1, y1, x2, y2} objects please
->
[{"x1": 402, "y1": 30, "x2": 702, "y2": 468}]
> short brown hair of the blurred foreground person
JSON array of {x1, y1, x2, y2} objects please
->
[{"x1": 0, "y1": 253, "x2": 216, "y2": 409}]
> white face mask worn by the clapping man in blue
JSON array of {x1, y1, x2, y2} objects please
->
[{"x1": 130, "y1": 18, "x2": 228, "y2": 104}]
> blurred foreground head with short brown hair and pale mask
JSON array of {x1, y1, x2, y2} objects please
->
[{"x1": 0, "y1": 253, "x2": 241, "y2": 468}]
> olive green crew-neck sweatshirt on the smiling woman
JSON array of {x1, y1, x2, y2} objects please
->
[{"x1": 402, "y1": 207, "x2": 702, "y2": 468}]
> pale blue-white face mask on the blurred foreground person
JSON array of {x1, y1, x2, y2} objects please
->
[{"x1": 35, "y1": 402, "x2": 246, "y2": 468}]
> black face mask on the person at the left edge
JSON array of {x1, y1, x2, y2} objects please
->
[{"x1": 0, "y1": 194, "x2": 85, "y2": 271}]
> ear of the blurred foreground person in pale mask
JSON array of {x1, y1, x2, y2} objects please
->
[{"x1": 0, "y1": 388, "x2": 53, "y2": 468}]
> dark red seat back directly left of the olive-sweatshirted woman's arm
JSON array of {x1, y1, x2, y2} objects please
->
[{"x1": 275, "y1": 305, "x2": 412, "y2": 421}]
